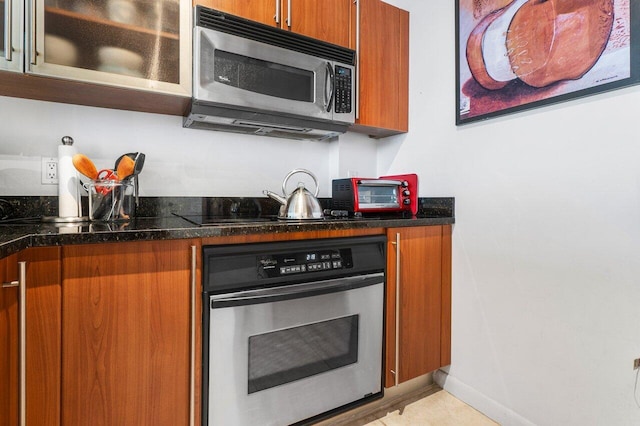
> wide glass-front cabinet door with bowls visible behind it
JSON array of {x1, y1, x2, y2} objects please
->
[{"x1": 26, "y1": 0, "x2": 191, "y2": 95}]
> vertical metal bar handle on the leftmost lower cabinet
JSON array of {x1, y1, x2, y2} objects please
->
[{"x1": 2, "y1": 262, "x2": 27, "y2": 426}]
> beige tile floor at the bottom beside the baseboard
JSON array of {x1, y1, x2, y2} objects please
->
[{"x1": 365, "y1": 390, "x2": 498, "y2": 426}]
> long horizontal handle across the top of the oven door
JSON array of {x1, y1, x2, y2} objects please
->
[{"x1": 210, "y1": 272, "x2": 384, "y2": 309}]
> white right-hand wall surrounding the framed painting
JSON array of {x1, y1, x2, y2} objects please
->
[{"x1": 378, "y1": 0, "x2": 640, "y2": 426}]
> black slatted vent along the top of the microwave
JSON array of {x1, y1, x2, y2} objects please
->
[{"x1": 195, "y1": 6, "x2": 356, "y2": 65}]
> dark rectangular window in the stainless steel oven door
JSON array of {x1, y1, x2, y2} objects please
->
[{"x1": 248, "y1": 315, "x2": 358, "y2": 393}]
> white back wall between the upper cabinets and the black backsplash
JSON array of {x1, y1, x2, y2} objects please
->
[{"x1": 0, "y1": 96, "x2": 376, "y2": 197}]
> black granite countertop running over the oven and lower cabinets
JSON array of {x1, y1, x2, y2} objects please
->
[{"x1": 0, "y1": 217, "x2": 455, "y2": 258}]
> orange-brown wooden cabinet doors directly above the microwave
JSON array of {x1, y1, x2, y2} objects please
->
[{"x1": 195, "y1": 0, "x2": 351, "y2": 47}]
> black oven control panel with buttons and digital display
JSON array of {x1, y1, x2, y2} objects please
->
[{"x1": 257, "y1": 249, "x2": 353, "y2": 278}]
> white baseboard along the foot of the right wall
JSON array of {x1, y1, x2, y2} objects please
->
[{"x1": 433, "y1": 370, "x2": 535, "y2": 426}]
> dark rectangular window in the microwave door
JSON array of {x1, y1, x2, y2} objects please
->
[{"x1": 213, "y1": 49, "x2": 315, "y2": 102}]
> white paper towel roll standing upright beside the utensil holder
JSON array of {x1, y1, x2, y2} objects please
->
[{"x1": 58, "y1": 136, "x2": 82, "y2": 217}]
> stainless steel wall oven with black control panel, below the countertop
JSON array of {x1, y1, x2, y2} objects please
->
[{"x1": 202, "y1": 236, "x2": 386, "y2": 426}]
